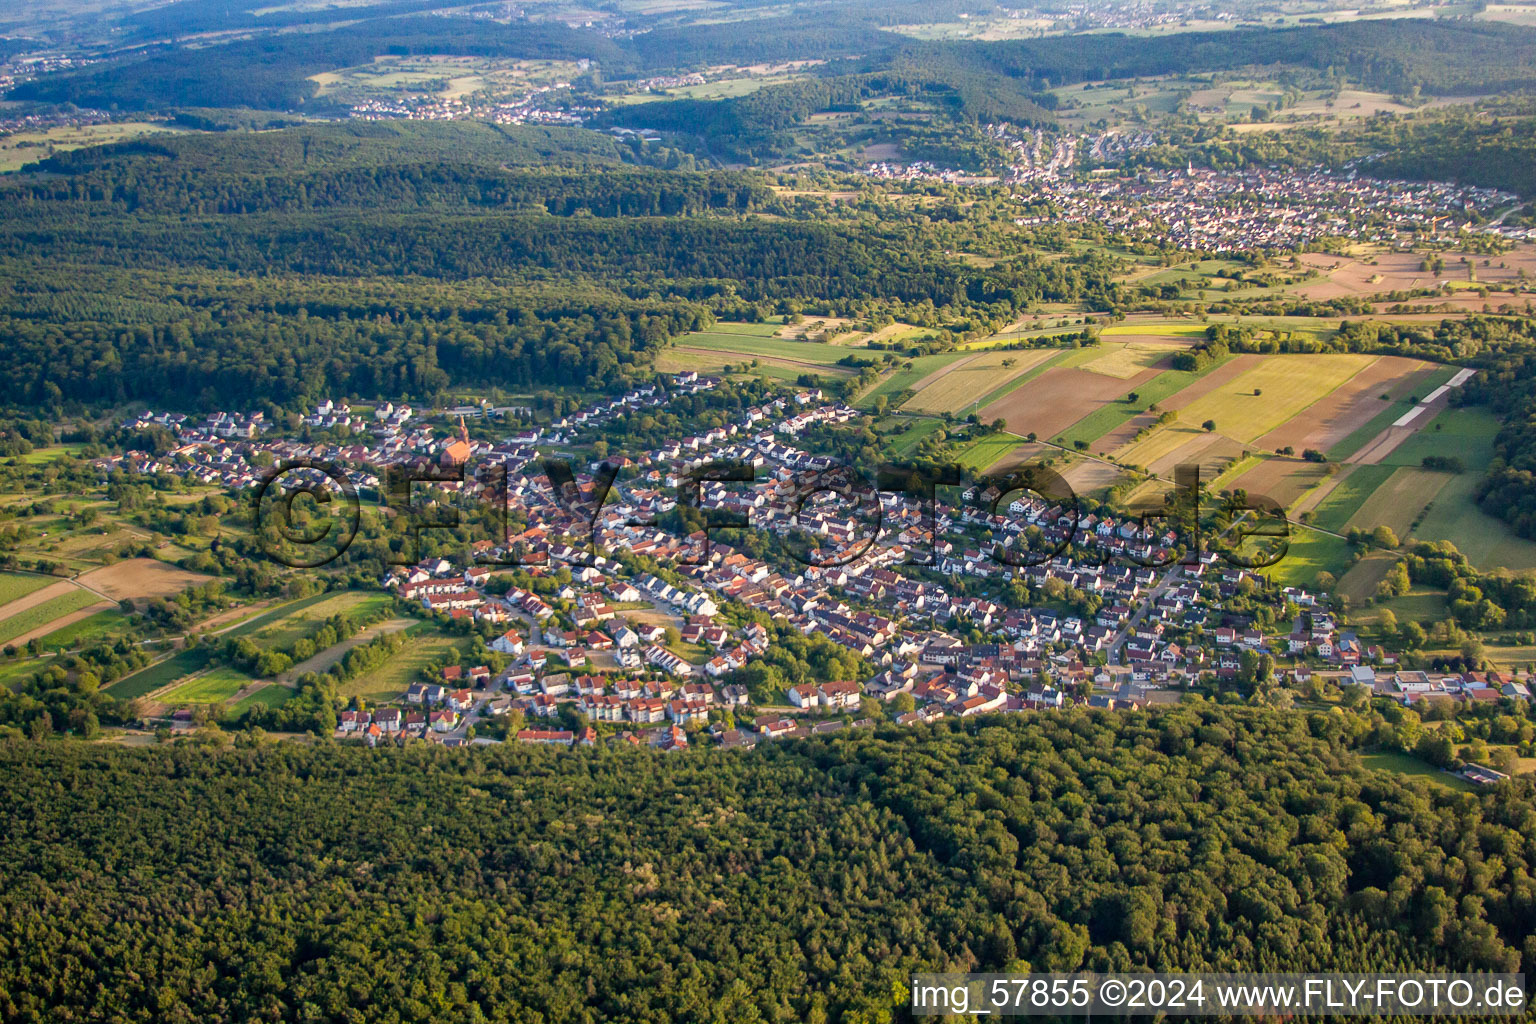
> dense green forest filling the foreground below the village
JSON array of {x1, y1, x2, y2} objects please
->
[{"x1": 0, "y1": 708, "x2": 1536, "y2": 1022}]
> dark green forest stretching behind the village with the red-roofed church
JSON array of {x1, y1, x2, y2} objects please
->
[{"x1": 0, "y1": 124, "x2": 1123, "y2": 408}]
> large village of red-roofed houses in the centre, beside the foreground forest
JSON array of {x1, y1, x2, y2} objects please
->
[{"x1": 98, "y1": 373, "x2": 1531, "y2": 781}]
